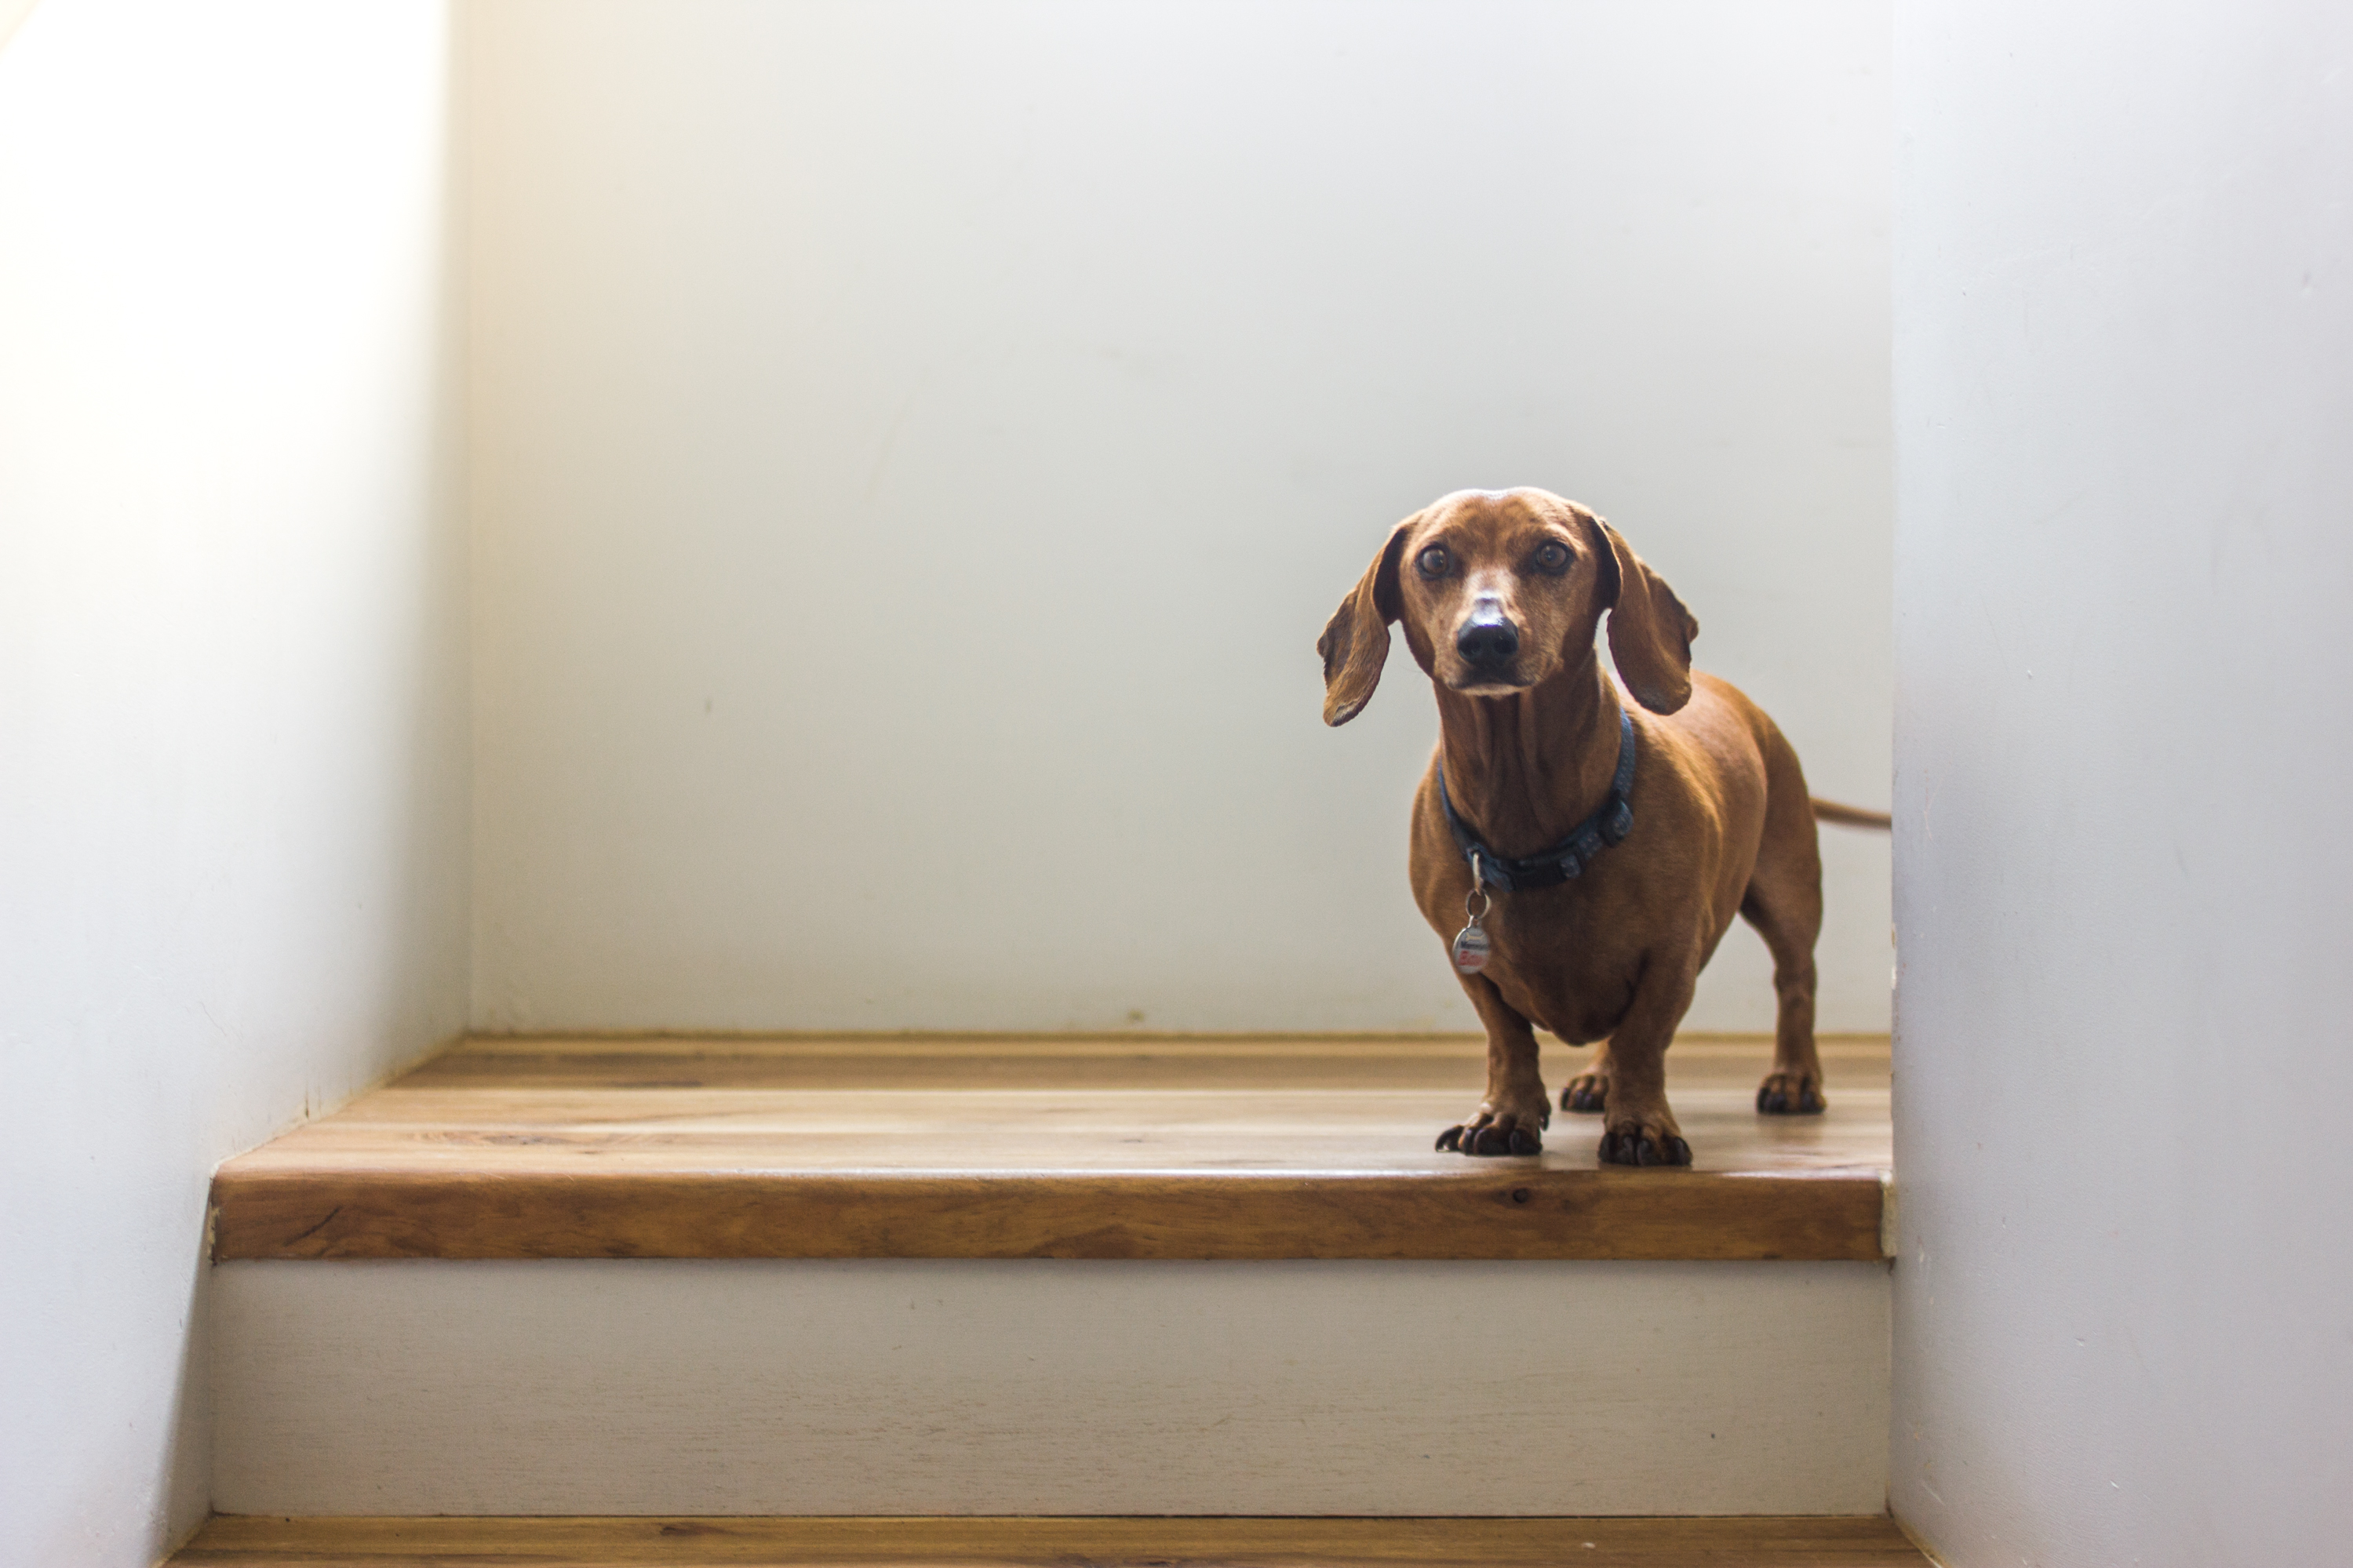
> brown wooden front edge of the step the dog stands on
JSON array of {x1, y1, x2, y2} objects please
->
[{"x1": 212, "y1": 1164, "x2": 1885, "y2": 1262}]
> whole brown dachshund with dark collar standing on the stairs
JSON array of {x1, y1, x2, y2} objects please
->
[{"x1": 1315, "y1": 489, "x2": 1885, "y2": 1166}]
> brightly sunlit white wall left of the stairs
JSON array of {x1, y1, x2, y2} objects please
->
[{"x1": 0, "y1": 0, "x2": 468, "y2": 1568}]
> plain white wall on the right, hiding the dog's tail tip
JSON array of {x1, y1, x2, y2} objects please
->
[{"x1": 1892, "y1": 0, "x2": 2353, "y2": 1568}]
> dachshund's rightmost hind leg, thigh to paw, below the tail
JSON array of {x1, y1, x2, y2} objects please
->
[{"x1": 1741, "y1": 731, "x2": 1823, "y2": 1117}]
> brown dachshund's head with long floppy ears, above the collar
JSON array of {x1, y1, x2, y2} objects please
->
[{"x1": 1315, "y1": 489, "x2": 1699, "y2": 724}]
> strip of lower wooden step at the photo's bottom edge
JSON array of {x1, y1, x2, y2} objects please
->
[{"x1": 172, "y1": 1516, "x2": 1927, "y2": 1568}]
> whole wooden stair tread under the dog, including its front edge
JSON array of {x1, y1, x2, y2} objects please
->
[{"x1": 214, "y1": 1037, "x2": 1889, "y2": 1260}]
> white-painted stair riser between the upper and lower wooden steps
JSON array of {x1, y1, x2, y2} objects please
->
[{"x1": 212, "y1": 1260, "x2": 1889, "y2": 1514}]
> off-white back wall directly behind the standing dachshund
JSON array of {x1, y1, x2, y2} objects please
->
[{"x1": 466, "y1": 0, "x2": 1892, "y2": 1030}]
